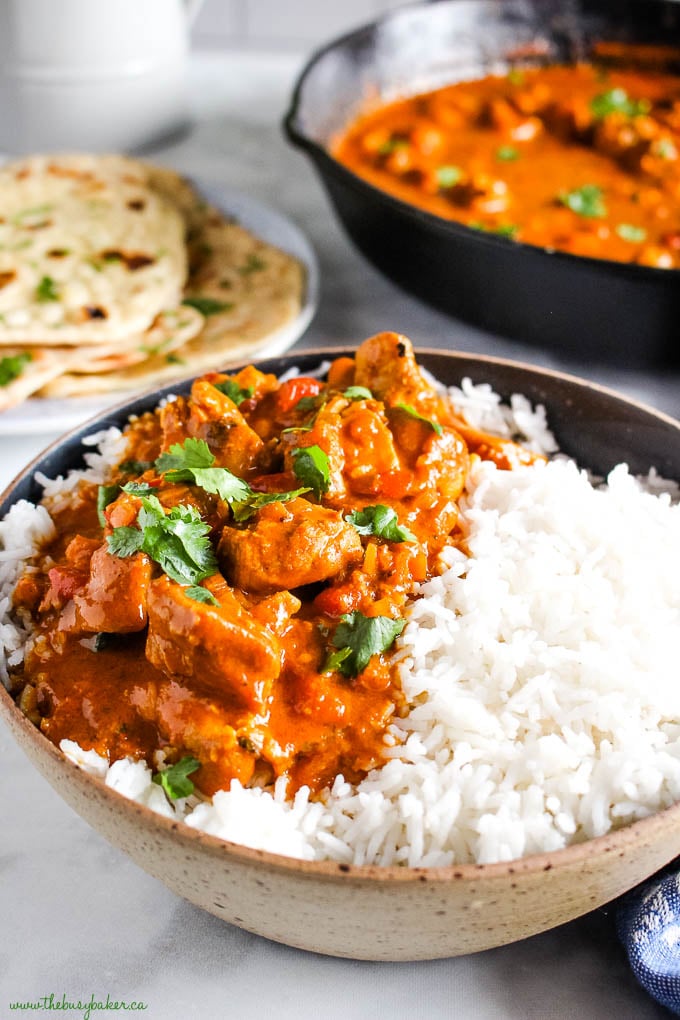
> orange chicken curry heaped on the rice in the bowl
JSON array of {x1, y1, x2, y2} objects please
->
[{"x1": 13, "y1": 334, "x2": 533, "y2": 795}]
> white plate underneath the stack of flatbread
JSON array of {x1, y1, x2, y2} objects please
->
[{"x1": 0, "y1": 179, "x2": 319, "y2": 437}]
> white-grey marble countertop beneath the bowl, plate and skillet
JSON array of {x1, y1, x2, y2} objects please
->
[{"x1": 0, "y1": 53, "x2": 680, "y2": 1020}]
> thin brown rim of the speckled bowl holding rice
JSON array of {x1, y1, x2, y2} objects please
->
[{"x1": 0, "y1": 347, "x2": 680, "y2": 885}]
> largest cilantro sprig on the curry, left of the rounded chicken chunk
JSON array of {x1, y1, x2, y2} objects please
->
[{"x1": 106, "y1": 496, "x2": 217, "y2": 584}]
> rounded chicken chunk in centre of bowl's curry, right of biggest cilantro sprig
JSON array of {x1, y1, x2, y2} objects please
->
[{"x1": 217, "y1": 499, "x2": 363, "y2": 594}]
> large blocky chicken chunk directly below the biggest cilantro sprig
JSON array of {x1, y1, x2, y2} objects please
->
[{"x1": 146, "y1": 576, "x2": 281, "y2": 712}]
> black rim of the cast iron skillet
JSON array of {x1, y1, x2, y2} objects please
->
[{"x1": 282, "y1": 0, "x2": 680, "y2": 287}]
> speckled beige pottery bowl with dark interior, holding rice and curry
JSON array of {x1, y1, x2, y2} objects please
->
[{"x1": 0, "y1": 350, "x2": 680, "y2": 960}]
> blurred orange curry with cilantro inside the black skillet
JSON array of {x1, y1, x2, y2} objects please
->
[{"x1": 332, "y1": 64, "x2": 680, "y2": 269}]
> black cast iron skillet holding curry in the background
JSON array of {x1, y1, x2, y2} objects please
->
[{"x1": 284, "y1": 0, "x2": 680, "y2": 366}]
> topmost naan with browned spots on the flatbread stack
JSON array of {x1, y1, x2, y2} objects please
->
[{"x1": 0, "y1": 155, "x2": 188, "y2": 346}]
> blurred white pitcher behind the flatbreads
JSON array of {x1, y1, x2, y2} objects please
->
[{"x1": 0, "y1": 0, "x2": 201, "y2": 155}]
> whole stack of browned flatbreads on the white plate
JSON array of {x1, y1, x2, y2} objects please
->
[{"x1": 0, "y1": 155, "x2": 305, "y2": 410}]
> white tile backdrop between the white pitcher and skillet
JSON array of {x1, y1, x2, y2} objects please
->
[{"x1": 192, "y1": 0, "x2": 404, "y2": 51}]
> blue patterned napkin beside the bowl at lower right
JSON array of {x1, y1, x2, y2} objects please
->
[{"x1": 617, "y1": 861, "x2": 680, "y2": 1016}]
